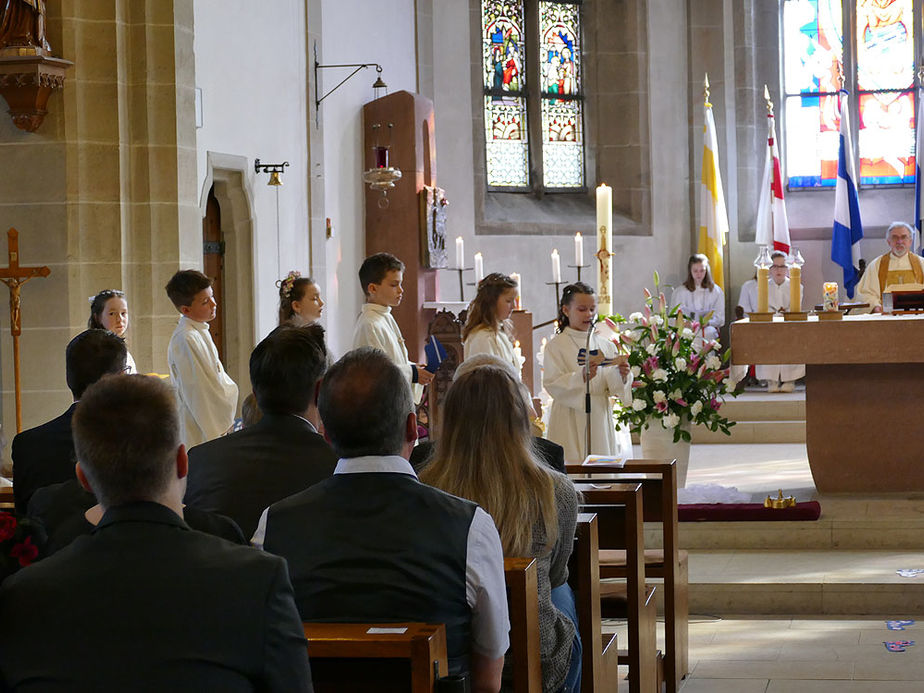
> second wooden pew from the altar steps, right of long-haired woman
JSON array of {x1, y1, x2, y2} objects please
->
[{"x1": 575, "y1": 483, "x2": 660, "y2": 693}]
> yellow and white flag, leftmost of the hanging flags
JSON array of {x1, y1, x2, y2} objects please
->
[{"x1": 696, "y1": 99, "x2": 728, "y2": 290}]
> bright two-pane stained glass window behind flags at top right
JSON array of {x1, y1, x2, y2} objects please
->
[{"x1": 782, "y1": 0, "x2": 920, "y2": 189}]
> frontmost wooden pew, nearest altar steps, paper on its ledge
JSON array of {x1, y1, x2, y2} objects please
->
[{"x1": 567, "y1": 460, "x2": 690, "y2": 691}]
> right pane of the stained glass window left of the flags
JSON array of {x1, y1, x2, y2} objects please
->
[{"x1": 539, "y1": 2, "x2": 584, "y2": 188}]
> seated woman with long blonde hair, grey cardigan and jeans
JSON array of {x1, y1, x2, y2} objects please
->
[{"x1": 420, "y1": 366, "x2": 581, "y2": 693}]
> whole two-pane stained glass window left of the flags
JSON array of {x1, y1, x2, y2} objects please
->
[{"x1": 481, "y1": 0, "x2": 584, "y2": 190}]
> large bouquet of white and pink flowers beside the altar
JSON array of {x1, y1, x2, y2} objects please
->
[{"x1": 614, "y1": 273, "x2": 735, "y2": 443}]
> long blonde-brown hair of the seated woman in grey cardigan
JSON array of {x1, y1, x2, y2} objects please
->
[{"x1": 420, "y1": 366, "x2": 558, "y2": 556}]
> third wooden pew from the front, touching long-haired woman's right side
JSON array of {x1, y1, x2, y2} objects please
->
[{"x1": 568, "y1": 513, "x2": 619, "y2": 693}]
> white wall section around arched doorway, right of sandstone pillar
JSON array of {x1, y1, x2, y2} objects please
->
[{"x1": 194, "y1": 0, "x2": 309, "y2": 344}]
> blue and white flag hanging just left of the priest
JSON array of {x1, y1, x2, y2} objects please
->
[{"x1": 831, "y1": 91, "x2": 863, "y2": 298}]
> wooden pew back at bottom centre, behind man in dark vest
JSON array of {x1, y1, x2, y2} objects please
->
[{"x1": 303, "y1": 623, "x2": 449, "y2": 693}]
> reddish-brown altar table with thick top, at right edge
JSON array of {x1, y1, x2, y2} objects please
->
[{"x1": 731, "y1": 314, "x2": 924, "y2": 493}]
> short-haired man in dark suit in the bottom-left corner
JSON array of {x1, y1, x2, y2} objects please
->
[{"x1": 0, "y1": 375, "x2": 312, "y2": 693}]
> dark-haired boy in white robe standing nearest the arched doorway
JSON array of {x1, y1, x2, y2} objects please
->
[{"x1": 165, "y1": 270, "x2": 238, "y2": 448}]
